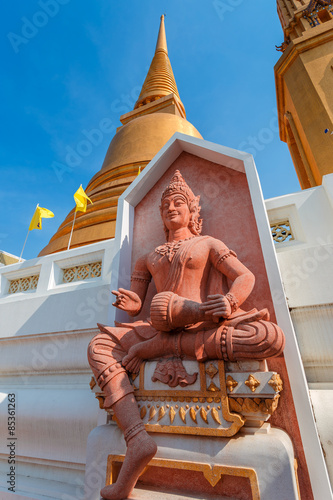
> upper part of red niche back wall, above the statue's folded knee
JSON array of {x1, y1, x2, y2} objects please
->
[{"x1": 132, "y1": 152, "x2": 275, "y2": 321}]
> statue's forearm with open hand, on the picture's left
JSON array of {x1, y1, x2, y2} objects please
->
[{"x1": 112, "y1": 256, "x2": 151, "y2": 316}]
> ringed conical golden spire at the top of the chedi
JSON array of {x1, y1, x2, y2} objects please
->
[{"x1": 134, "y1": 16, "x2": 186, "y2": 118}]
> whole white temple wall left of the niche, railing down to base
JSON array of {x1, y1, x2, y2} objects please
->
[{"x1": 0, "y1": 240, "x2": 114, "y2": 500}]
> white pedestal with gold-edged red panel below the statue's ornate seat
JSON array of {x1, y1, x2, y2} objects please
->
[{"x1": 85, "y1": 423, "x2": 299, "y2": 500}]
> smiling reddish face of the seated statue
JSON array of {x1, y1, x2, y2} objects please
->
[{"x1": 161, "y1": 193, "x2": 191, "y2": 230}]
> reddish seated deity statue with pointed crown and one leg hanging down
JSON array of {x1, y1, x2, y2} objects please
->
[{"x1": 88, "y1": 171, "x2": 284, "y2": 500}]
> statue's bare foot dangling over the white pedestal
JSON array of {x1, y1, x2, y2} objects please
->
[{"x1": 101, "y1": 430, "x2": 157, "y2": 500}]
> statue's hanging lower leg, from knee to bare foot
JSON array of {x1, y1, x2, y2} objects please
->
[{"x1": 88, "y1": 333, "x2": 157, "y2": 500}]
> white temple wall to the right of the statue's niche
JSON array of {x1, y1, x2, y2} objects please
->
[{"x1": 265, "y1": 174, "x2": 333, "y2": 483}]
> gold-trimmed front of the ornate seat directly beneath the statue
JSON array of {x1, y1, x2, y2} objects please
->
[{"x1": 135, "y1": 361, "x2": 245, "y2": 437}]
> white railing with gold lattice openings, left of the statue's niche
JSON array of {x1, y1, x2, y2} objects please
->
[{"x1": 0, "y1": 239, "x2": 114, "y2": 338}]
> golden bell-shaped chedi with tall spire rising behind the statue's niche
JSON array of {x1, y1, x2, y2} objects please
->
[{"x1": 39, "y1": 16, "x2": 201, "y2": 255}]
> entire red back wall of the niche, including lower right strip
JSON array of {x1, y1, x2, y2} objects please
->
[{"x1": 132, "y1": 152, "x2": 313, "y2": 500}]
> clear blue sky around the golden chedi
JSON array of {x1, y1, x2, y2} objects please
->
[{"x1": 0, "y1": 0, "x2": 300, "y2": 259}]
